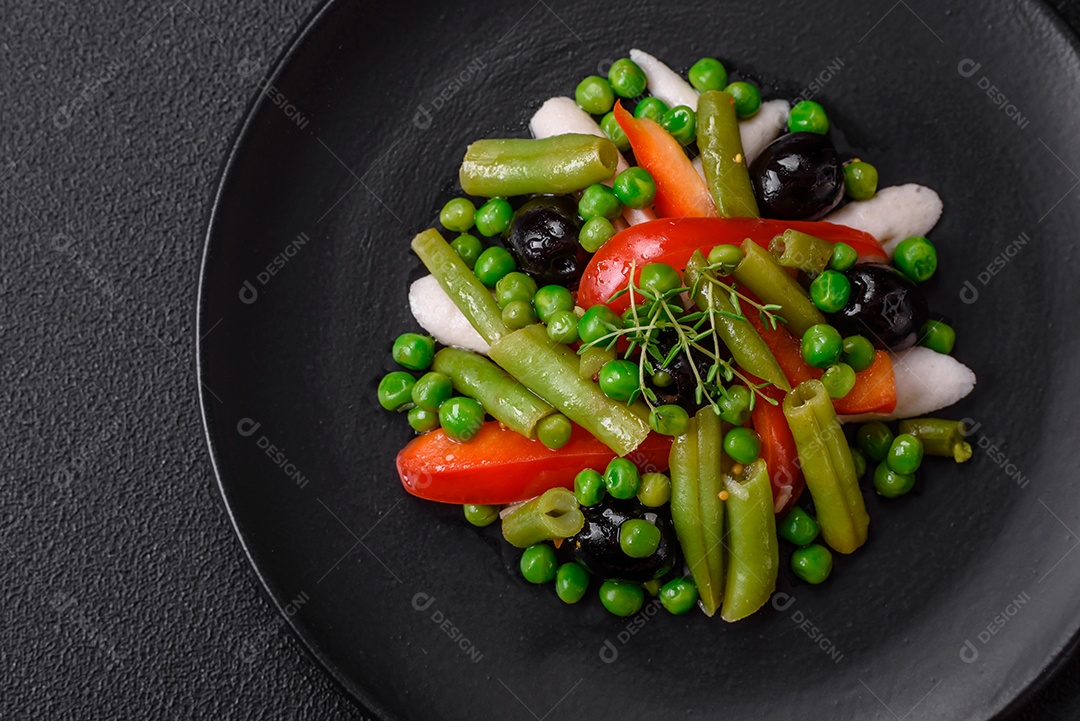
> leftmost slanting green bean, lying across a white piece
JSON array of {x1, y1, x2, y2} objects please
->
[{"x1": 413, "y1": 228, "x2": 510, "y2": 343}]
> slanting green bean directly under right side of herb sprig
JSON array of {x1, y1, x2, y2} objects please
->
[{"x1": 686, "y1": 250, "x2": 792, "y2": 391}]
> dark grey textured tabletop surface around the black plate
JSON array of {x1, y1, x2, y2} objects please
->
[{"x1": 6, "y1": 0, "x2": 1080, "y2": 721}]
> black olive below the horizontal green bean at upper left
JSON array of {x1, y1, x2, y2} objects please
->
[{"x1": 507, "y1": 195, "x2": 586, "y2": 287}]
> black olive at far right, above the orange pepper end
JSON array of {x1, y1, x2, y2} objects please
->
[{"x1": 828, "y1": 263, "x2": 930, "y2": 351}]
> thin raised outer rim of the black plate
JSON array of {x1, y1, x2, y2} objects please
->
[{"x1": 192, "y1": 0, "x2": 1080, "y2": 721}]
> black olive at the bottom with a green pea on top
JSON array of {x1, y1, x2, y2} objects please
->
[{"x1": 568, "y1": 496, "x2": 678, "y2": 581}]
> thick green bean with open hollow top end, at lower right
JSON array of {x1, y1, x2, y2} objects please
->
[{"x1": 784, "y1": 381, "x2": 869, "y2": 554}]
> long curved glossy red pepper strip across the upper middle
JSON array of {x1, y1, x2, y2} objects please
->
[{"x1": 578, "y1": 216, "x2": 888, "y2": 313}]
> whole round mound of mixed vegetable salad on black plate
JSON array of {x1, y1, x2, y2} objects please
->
[{"x1": 378, "y1": 50, "x2": 975, "y2": 622}]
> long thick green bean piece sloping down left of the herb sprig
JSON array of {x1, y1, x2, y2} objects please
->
[{"x1": 489, "y1": 324, "x2": 649, "y2": 455}]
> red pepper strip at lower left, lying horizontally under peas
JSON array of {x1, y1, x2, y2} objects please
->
[{"x1": 397, "y1": 421, "x2": 672, "y2": 504}]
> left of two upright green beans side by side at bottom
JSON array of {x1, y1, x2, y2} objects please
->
[{"x1": 670, "y1": 421, "x2": 721, "y2": 616}]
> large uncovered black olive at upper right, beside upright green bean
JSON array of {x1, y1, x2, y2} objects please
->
[{"x1": 750, "y1": 133, "x2": 843, "y2": 220}]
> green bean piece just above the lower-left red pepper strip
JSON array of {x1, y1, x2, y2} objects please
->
[{"x1": 434, "y1": 348, "x2": 555, "y2": 438}]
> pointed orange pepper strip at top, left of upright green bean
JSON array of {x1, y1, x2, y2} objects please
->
[{"x1": 615, "y1": 100, "x2": 717, "y2": 220}]
